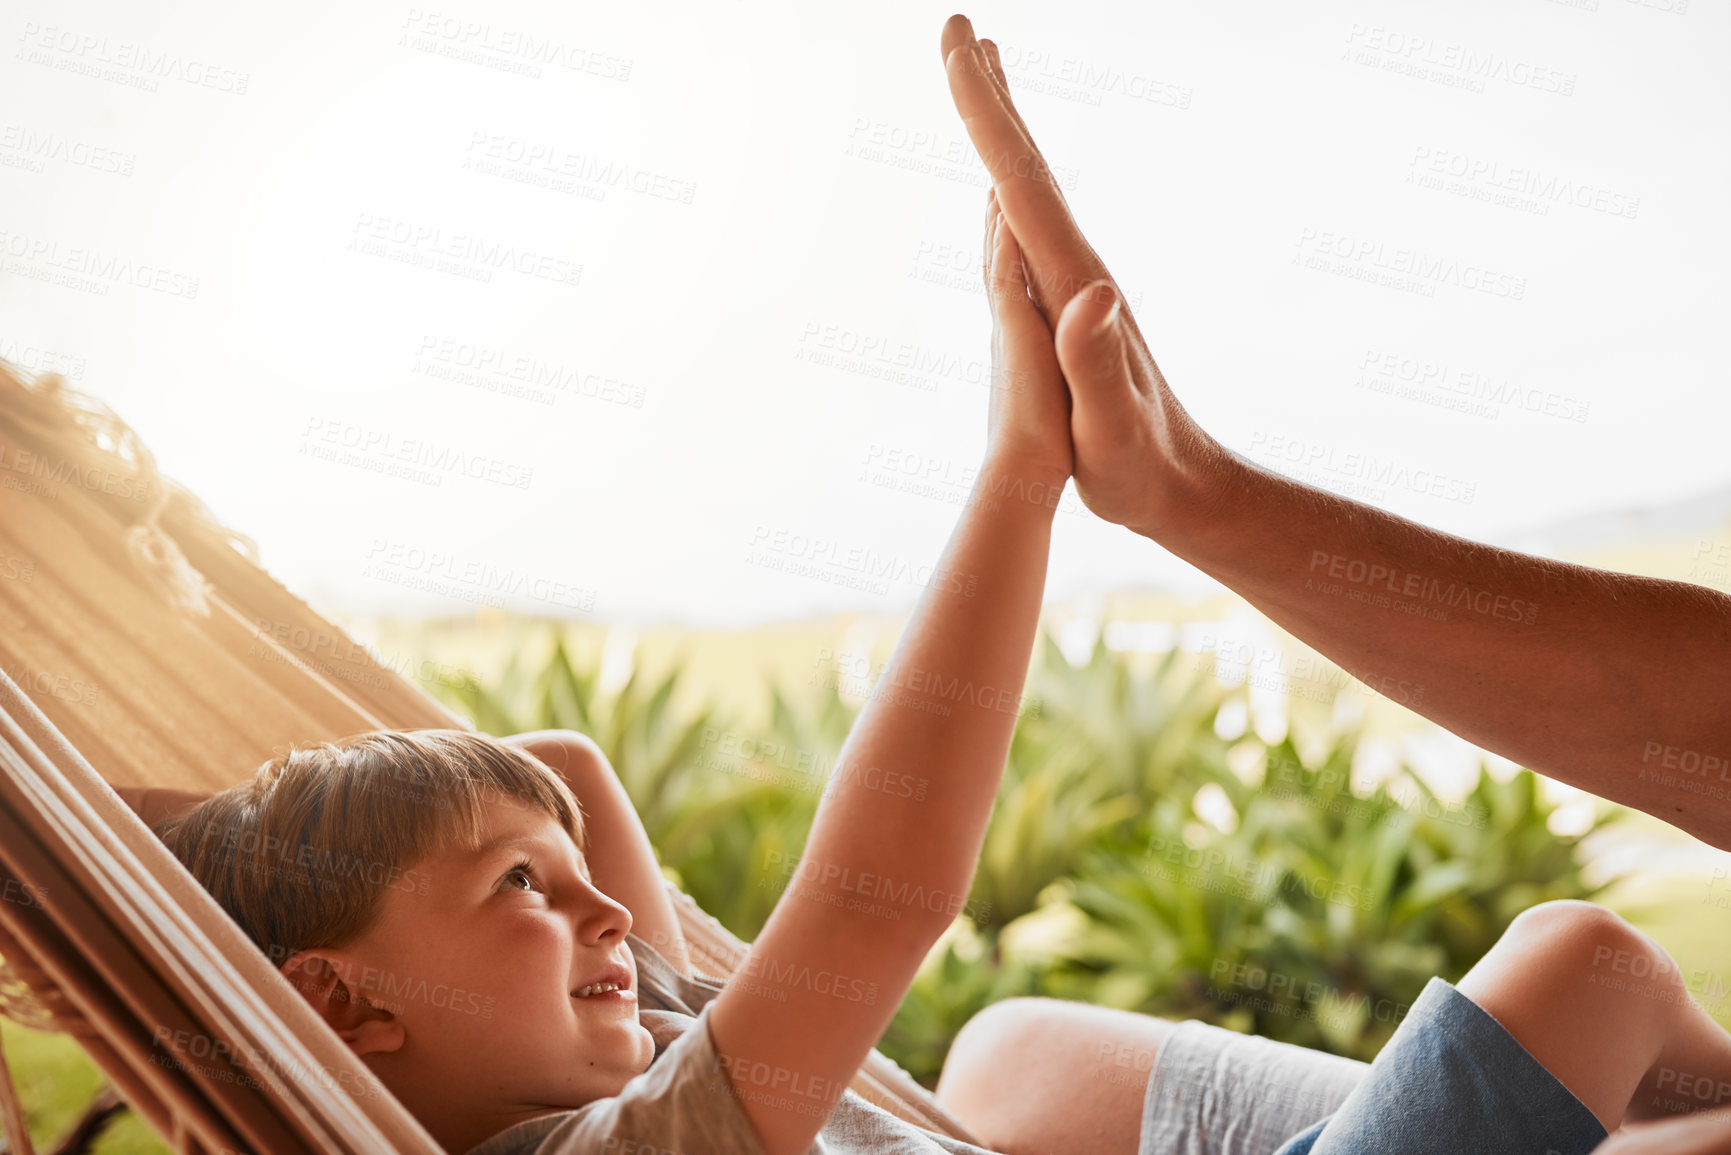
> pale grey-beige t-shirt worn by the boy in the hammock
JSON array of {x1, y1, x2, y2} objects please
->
[{"x1": 469, "y1": 935, "x2": 995, "y2": 1155}]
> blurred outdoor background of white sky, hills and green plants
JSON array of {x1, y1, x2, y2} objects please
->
[{"x1": 0, "y1": 0, "x2": 1731, "y2": 1150}]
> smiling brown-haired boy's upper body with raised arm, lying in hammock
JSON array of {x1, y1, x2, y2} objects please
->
[{"x1": 141, "y1": 182, "x2": 1070, "y2": 1155}]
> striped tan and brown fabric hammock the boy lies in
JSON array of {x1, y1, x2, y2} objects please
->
[{"x1": 0, "y1": 360, "x2": 975, "y2": 1155}]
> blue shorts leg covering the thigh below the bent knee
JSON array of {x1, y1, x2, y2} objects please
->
[{"x1": 1276, "y1": 978, "x2": 1605, "y2": 1155}]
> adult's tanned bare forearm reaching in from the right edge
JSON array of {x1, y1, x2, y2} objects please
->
[{"x1": 1155, "y1": 457, "x2": 1731, "y2": 847}]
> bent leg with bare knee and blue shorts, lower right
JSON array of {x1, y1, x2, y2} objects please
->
[{"x1": 1279, "y1": 902, "x2": 1731, "y2": 1155}]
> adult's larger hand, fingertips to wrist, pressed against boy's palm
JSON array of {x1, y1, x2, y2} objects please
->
[{"x1": 942, "y1": 16, "x2": 1231, "y2": 537}]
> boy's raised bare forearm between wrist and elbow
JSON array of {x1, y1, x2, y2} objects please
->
[{"x1": 791, "y1": 462, "x2": 1063, "y2": 933}]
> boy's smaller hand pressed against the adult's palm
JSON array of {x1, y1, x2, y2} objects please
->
[{"x1": 983, "y1": 189, "x2": 1075, "y2": 485}]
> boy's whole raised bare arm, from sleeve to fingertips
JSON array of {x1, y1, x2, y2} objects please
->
[{"x1": 710, "y1": 199, "x2": 1070, "y2": 1155}]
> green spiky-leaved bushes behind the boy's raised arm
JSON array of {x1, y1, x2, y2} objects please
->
[{"x1": 422, "y1": 619, "x2": 1605, "y2": 1086}]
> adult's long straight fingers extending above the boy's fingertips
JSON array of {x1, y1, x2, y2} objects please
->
[{"x1": 943, "y1": 16, "x2": 1110, "y2": 319}]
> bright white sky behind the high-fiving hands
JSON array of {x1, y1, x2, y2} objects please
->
[{"x1": 0, "y1": 0, "x2": 1731, "y2": 623}]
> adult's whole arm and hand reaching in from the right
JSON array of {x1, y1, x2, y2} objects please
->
[{"x1": 943, "y1": 16, "x2": 1731, "y2": 849}]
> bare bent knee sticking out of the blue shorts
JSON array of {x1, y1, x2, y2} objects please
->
[{"x1": 1459, "y1": 902, "x2": 1731, "y2": 1131}]
